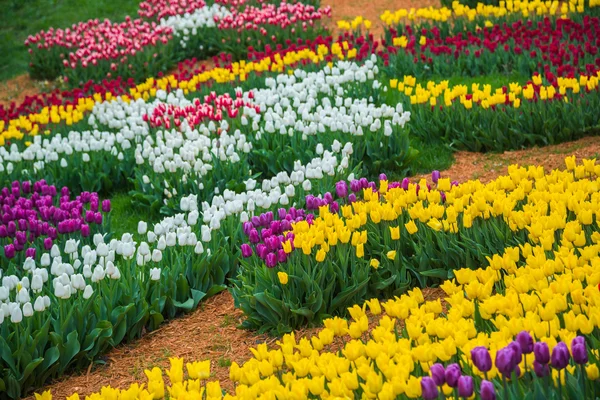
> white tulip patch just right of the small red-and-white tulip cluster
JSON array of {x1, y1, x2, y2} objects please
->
[{"x1": 242, "y1": 55, "x2": 410, "y2": 139}]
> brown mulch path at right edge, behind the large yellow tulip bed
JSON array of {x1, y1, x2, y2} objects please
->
[{"x1": 413, "y1": 136, "x2": 600, "y2": 183}]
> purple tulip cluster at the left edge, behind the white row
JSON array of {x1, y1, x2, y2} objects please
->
[{"x1": 0, "y1": 180, "x2": 110, "y2": 258}]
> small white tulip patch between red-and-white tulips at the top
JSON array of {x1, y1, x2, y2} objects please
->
[{"x1": 160, "y1": 3, "x2": 231, "y2": 48}]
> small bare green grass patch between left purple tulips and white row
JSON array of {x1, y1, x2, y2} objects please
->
[{"x1": 108, "y1": 193, "x2": 157, "y2": 238}]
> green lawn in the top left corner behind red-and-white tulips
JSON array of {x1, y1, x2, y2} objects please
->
[{"x1": 0, "y1": 0, "x2": 139, "y2": 80}]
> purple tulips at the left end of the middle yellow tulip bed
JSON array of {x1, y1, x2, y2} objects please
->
[{"x1": 240, "y1": 207, "x2": 314, "y2": 268}]
